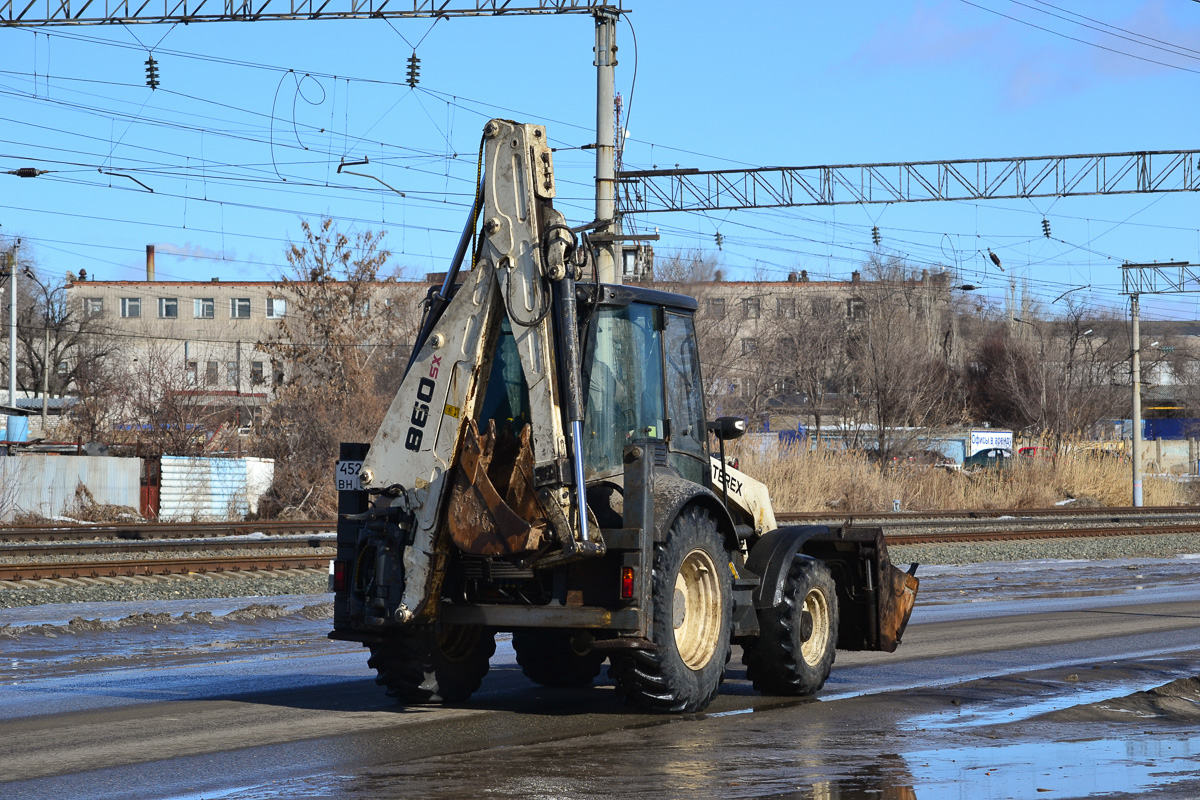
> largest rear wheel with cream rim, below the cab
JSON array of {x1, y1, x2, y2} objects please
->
[{"x1": 608, "y1": 506, "x2": 733, "y2": 712}]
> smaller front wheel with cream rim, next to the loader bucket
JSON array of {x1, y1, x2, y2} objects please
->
[{"x1": 742, "y1": 555, "x2": 838, "y2": 694}]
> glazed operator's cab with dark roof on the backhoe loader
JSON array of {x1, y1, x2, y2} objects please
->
[{"x1": 580, "y1": 285, "x2": 709, "y2": 486}]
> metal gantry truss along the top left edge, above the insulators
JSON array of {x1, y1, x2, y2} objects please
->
[{"x1": 0, "y1": 0, "x2": 625, "y2": 28}]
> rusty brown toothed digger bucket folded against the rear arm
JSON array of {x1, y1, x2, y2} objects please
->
[{"x1": 446, "y1": 420, "x2": 548, "y2": 555}]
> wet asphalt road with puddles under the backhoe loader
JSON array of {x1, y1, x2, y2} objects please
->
[{"x1": 0, "y1": 575, "x2": 1200, "y2": 800}]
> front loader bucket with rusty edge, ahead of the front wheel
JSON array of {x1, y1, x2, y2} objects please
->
[{"x1": 802, "y1": 528, "x2": 920, "y2": 652}]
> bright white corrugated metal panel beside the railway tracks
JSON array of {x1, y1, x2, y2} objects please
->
[{"x1": 158, "y1": 456, "x2": 257, "y2": 522}]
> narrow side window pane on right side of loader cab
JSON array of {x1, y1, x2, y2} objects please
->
[{"x1": 664, "y1": 313, "x2": 708, "y2": 483}]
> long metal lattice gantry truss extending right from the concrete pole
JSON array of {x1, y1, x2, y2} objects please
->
[{"x1": 618, "y1": 150, "x2": 1200, "y2": 213}]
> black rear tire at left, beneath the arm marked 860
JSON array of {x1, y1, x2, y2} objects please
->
[{"x1": 367, "y1": 625, "x2": 496, "y2": 703}]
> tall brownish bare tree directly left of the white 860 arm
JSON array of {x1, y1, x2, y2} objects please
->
[{"x1": 258, "y1": 219, "x2": 418, "y2": 516}]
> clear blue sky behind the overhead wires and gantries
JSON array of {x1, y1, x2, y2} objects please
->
[{"x1": 0, "y1": 0, "x2": 1200, "y2": 318}]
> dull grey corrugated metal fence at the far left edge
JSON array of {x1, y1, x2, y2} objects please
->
[{"x1": 0, "y1": 455, "x2": 142, "y2": 522}]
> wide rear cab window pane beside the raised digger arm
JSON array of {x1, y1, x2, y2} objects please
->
[{"x1": 583, "y1": 303, "x2": 666, "y2": 480}]
